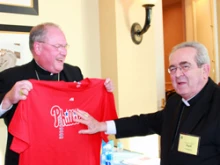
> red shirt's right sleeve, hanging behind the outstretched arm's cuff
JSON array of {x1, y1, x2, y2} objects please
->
[{"x1": 101, "y1": 91, "x2": 118, "y2": 142}]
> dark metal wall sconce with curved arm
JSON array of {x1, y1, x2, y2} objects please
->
[{"x1": 131, "y1": 4, "x2": 154, "y2": 44}]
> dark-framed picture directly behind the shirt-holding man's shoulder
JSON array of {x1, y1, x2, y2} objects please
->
[{"x1": 0, "y1": 24, "x2": 33, "y2": 72}]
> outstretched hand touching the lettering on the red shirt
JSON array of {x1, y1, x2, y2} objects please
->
[{"x1": 74, "y1": 110, "x2": 107, "y2": 134}]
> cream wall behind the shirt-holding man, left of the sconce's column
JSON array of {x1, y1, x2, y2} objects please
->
[{"x1": 0, "y1": 0, "x2": 101, "y2": 165}]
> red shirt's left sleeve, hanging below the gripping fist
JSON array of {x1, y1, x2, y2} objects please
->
[{"x1": 8, "y1": 100, "x2": 29, "y2": 153}]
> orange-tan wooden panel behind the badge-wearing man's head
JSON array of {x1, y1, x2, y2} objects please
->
[{"x1": 185, "y1": 0, "x2": 220, "y2": 83}]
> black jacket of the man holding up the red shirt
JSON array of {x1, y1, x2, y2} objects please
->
[{"x1": 0, "y1": 60, "x2": 83, "y2": 165}]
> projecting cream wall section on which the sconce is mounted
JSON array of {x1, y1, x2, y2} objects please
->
[{"x1": 100, "y1": 0, "x2": 164, "y2": 157}]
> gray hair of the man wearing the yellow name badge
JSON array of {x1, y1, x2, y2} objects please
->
[{"x1": 169, "y1": 41, "x2": 210, "y2": 67}]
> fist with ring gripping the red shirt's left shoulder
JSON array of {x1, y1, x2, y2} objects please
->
[{"x1": 2, "y1": 80, "x2": 33, "y2": 109}]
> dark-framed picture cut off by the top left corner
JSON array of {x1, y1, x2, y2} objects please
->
[{"x1": 0, "y1": 0, "x2": 39, "y2": 15}]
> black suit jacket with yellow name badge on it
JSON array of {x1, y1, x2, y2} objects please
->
[{"x1": 115, "y1": 79, "x2": 220, "y2": 165}]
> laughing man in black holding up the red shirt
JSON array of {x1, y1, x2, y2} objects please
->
[{"x1": 0, "y1": 23, "x2": 112, "y2": 165}]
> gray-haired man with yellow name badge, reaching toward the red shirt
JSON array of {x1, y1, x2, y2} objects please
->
[{"x1": 76, "y1": 42, "x2": 220, "y2": 165}]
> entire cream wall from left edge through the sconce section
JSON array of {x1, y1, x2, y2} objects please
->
[{"x1": 0, "y1": 0, "x2": 164, "y2": 162}]
